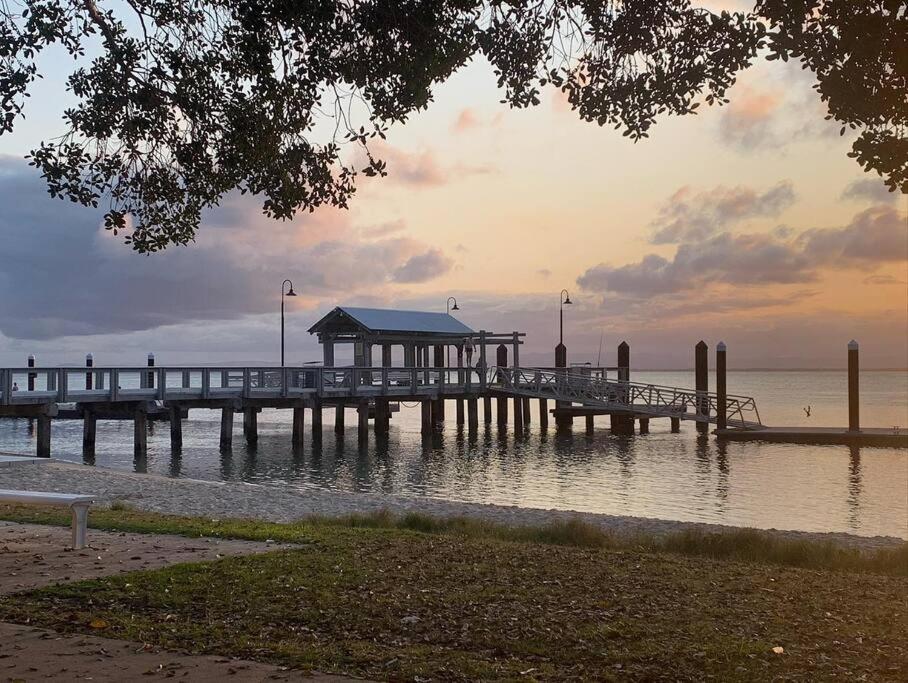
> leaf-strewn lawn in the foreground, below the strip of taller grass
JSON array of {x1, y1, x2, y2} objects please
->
[{"x1": 0, "y1": 524, "x2": 908, "y2": 681}]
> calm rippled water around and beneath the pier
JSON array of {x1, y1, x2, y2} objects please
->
[{"x1": 0, "y1": 372, "x2": 908, "y2": 538}]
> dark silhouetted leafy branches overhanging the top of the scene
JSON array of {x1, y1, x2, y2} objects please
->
[{"x1": 0, "y1": 0, "x2": 908, "y2": 252}]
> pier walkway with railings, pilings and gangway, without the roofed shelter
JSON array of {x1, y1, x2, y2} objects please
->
[{"x1": 0, "y1": 366, "x2": 762, "y2": 455}]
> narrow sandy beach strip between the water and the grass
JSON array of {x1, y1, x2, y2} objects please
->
[{"x1": 0, "y1": 460, "x2": 906, "y2": 550}]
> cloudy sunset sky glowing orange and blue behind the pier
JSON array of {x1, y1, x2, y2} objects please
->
[{"x1": 0, "y1": 4, "x2": 908, "y2": 368}]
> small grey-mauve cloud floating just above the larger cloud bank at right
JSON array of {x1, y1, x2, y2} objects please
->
[{"x1": 651, "y1": 180, "x2": 795, "y2": 244}]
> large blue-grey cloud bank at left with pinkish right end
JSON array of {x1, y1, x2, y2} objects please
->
[{"x1": 0, "y1": 157, "x2": 454, "y2": 339}]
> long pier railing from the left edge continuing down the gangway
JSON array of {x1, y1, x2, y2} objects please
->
[{"x1": 0, "y1": 366, "x2": 761, "y2": 428}]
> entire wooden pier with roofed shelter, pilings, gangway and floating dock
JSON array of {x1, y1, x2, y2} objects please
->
[{"x1": 0, "y1": 308, "x2": 892, "y2": 457}]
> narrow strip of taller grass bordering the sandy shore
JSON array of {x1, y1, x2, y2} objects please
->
[{"x1": 0, "y1": 501, "x2": 908, "y2": 576}]
